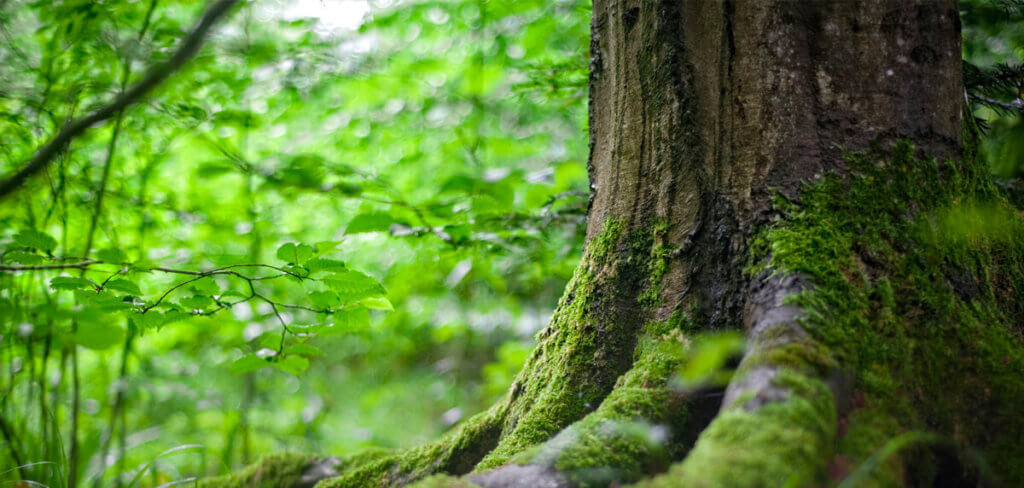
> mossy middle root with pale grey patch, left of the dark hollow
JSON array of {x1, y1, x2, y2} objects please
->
[{"x1": 468, "y1": 316, "x2": 721, "y2": 487}]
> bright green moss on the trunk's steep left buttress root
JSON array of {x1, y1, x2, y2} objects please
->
[{"x1": 477, "y1": 220, "x2": 649, "y2": 470}]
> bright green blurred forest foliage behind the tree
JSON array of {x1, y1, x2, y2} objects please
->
[{"x1": 0, "y1": 0, "x2": 1024, "y2": 487}]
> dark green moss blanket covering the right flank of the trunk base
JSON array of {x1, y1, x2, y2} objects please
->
[{"x1": 745, "y1": 142, "x2": 1024, "y2": 486}]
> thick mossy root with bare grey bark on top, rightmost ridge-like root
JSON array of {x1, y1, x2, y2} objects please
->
[{"x1": 642, "y1": 277, "x2": 845, "y2": 488}]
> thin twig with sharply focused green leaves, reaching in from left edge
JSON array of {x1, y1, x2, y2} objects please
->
[{"x1": 0, "y1": 234, "x2": 391, "y2": 364}]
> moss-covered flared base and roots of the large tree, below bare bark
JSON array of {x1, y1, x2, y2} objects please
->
[{"x1": 203, "y1": 143, "x2": 1024, "y2": 488}]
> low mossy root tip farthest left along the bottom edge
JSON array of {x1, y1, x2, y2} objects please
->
[{"x1": 199, "y1": 452, "x2": 343, "y2": 488}]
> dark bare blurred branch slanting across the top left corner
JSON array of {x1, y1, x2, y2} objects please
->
[{"x1": 0, "y1": 0, "x2": 238, "y2": 197}]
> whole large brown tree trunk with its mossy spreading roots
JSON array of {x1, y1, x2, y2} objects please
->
[{"x1": 199, "y1": 0, "x2": 1024, "y2": 488}]
